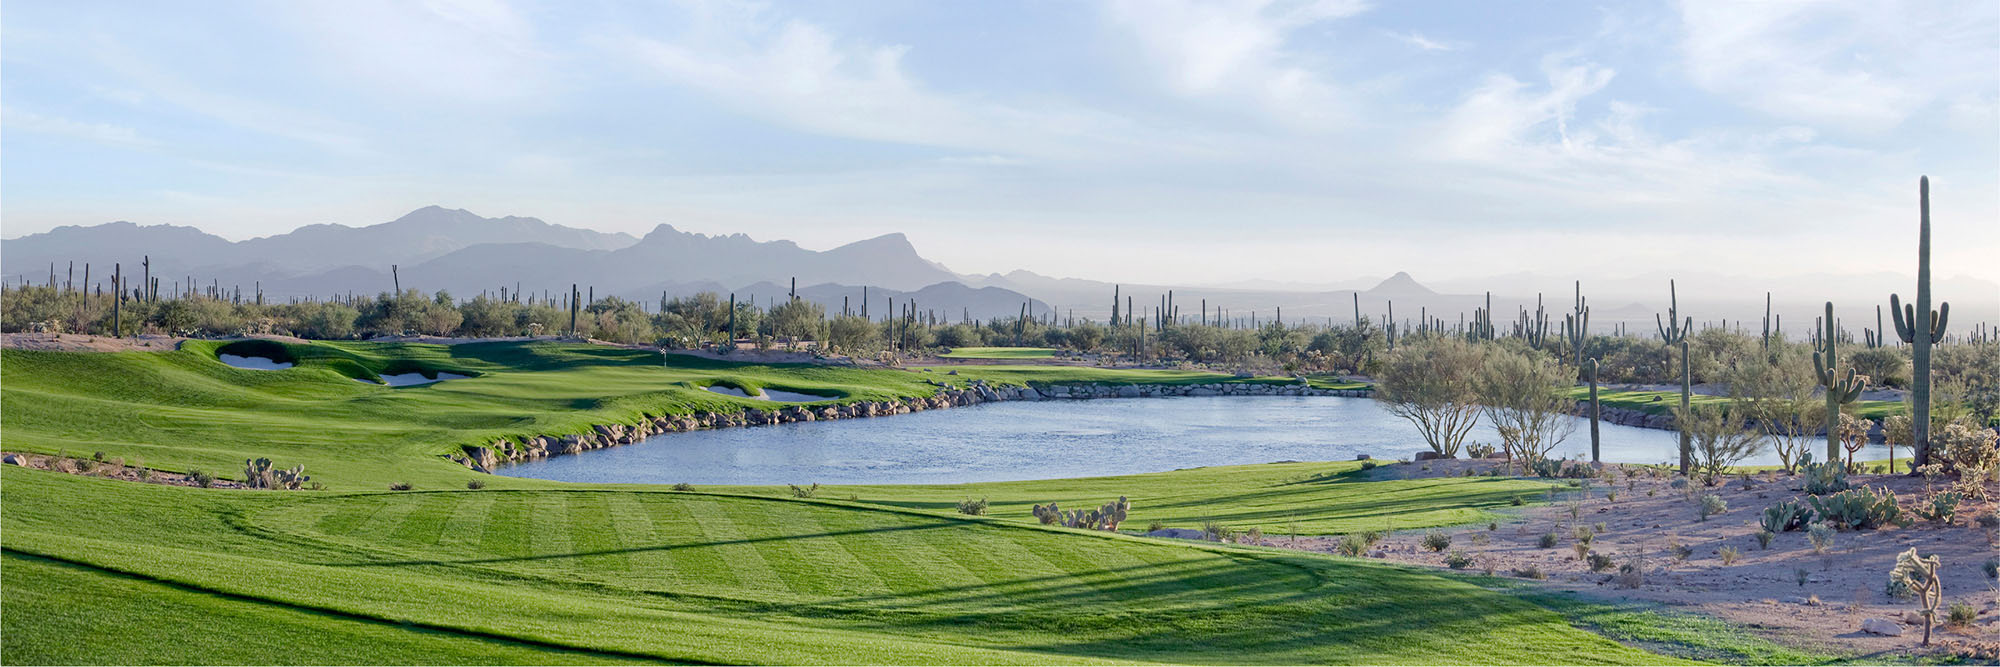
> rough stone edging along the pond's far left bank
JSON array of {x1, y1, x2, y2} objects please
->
[{"x1": 450, "y1": 379, "x2": 1374, "y2": 471}]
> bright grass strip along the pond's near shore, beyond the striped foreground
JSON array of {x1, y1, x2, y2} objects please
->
[{"x1": 730, "y1": 461, "x2": 1550, "y2": 535}]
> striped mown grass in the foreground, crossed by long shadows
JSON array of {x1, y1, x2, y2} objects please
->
[{"x1": 0, "y1": 467, "x2": 1660, "y2": 663}]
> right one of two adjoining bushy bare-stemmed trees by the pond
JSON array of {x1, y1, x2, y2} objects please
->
[{"x1": 1474, "y1": 349, "x2": 1576, "y2": 465}]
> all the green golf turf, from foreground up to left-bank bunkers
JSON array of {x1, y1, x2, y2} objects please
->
[{"x1": 0, "y1": 343, "x2": 1816, "y2": 663}]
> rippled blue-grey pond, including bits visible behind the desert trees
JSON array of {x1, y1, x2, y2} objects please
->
[{"x1": 498, "y1": 395, "x2": 1888, "y2": 483}]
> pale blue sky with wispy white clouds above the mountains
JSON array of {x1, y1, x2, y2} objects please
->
[{"x1": 0, "y1": 0, "x2": 2000, "y2": 284}]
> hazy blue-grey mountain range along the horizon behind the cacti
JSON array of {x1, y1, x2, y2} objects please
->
[{"x1": 0, "y1": 206, "x2": 2000, "y2": 332}]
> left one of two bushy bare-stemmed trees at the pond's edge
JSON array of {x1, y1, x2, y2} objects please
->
[{"x1": 1376, "y1": 337, "x2": 1484, "y2": 457}]
